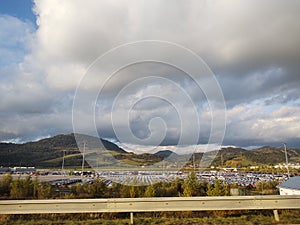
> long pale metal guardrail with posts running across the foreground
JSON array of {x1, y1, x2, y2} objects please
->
[{"x1": 0, "y1": 195, "x2": 300, "y2": 223}]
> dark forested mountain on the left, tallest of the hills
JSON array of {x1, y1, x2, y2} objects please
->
[{"x1": 0, "y1": 134, "x2": 127, "y2": 167}]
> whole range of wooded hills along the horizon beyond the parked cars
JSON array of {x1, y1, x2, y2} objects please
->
[{"x1": 0, "y1": 134, "x2": 300, "y2": 167}]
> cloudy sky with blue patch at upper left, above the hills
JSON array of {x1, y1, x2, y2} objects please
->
[{"x1": 0, "y1": 0, "x2": 300, "y2": 152}]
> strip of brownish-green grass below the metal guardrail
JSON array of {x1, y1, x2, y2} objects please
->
[{"x1": 0, "y1": 210, "x2": 300, "y2": 225}]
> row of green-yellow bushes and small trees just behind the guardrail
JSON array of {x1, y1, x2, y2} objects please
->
[{"x1": 0, "y1": 172, "x2": 278, "y2": 199}]
